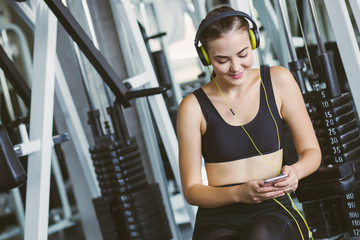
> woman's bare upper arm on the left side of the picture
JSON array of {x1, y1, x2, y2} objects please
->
[{"x1": 177, "y1": 94, "x2": 203, "y2": 197}]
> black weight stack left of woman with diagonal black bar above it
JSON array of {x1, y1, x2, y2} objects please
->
[{"x1": 45, "y1": 1, "x2": 177, "y2": 239}]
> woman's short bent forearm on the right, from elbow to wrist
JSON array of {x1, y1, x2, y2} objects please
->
[{"x1": 292, "y1": 148, "x2": 321, "y2": 180}]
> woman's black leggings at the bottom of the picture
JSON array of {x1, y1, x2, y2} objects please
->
[{"x1": 193, "y1": 198, "x2": 309, "y2": 240}]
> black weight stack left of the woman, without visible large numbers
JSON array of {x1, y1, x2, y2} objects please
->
[{"x1": 90, "y1": 137, "x2": 172, "y2": 240}]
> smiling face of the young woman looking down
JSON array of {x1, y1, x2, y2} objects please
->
[{"x1": 208, "y1": 30, "x2": 253, "y2": 85}]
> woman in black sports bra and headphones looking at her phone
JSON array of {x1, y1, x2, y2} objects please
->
[{"x1": 177, "y1": 7, "x2": 321, "y2": 240}]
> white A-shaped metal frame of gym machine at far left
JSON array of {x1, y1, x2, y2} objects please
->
[{"x1": 4, "y1": 2, "x2": 106, "y2": 239}]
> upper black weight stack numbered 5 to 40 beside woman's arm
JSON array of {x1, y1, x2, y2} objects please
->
[{"x1": 308, "y1": 91, "x2": 360, "y2": 166}]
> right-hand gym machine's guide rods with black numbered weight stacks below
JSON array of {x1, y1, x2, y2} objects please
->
[{"x1": 276, "y1": 0, "x2": 360, "y2": 239}]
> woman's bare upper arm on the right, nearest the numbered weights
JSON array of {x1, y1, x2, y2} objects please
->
[{"x1": 271, "y1": 67, "x2": 319, "y2": 155}]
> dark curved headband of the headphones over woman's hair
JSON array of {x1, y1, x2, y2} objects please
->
[{"x1": 195, "y1": 11, "x2": 257, "y2": 47}]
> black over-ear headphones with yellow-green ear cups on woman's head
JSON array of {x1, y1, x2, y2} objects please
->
[{"x1": 194, "y1": 11, "x2": 260, "y2": 66}]
